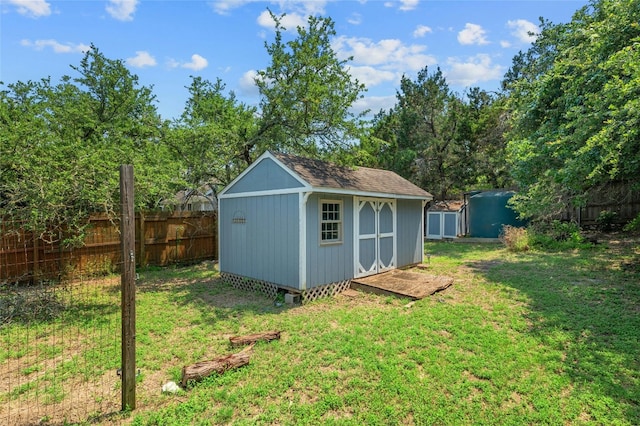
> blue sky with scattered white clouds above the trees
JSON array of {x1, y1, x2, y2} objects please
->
[{"x1": 0, "y1": 0, "x2": 587, "y2": 119}]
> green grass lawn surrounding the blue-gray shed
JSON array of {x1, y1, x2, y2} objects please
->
[{"x1": 0, "y1": 241, "x2": 640, "y2": 425}]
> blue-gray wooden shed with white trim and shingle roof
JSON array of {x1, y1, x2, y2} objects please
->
[{"x1": 218, "y1": 151, "x2": 433, "y2": 298}]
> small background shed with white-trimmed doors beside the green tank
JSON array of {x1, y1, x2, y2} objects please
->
[{"x1": 425, "y1": 201, "x2": 466, "y2": 240}]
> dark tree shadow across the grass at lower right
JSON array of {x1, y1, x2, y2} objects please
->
[{"x1": 467, "y1": 247, "x2": 640, "y2": 424}]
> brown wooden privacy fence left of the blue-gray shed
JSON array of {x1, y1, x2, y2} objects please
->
[{"x1": 0, "y1": 212, "x2": 218, "y2": 284}]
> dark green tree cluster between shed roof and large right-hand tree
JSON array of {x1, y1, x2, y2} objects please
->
[{"x1": 354, "y1": 67, "x2": 510, "y2": 200}]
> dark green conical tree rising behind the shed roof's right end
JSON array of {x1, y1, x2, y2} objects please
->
[{"x1": 361, "y1": 67, "x2": 472, "y2": 200}]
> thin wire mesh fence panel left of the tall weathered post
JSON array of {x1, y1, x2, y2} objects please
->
[{"x1": 0, "y1": 238, "x2": 120, "y2": 425}]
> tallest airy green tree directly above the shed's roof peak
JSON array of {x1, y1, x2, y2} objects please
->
[{"x1": 256, "y1": 12, "x2": 365, "y2": 156}]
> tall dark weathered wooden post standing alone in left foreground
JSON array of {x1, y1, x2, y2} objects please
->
[{"x1": 120, "y1": 165, "x2": 136, "y2": 411}]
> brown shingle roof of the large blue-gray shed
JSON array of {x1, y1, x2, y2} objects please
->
[{"x1": 272, "y1": 153, "x2": 433, "y2": 199}]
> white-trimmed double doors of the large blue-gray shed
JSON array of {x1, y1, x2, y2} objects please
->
[{"x1": 355, "y1": 197, "x2": 396, "y2": 278}]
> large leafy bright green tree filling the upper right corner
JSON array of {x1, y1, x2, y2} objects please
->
[{"x1": 504, "y1": 0, "x2": 640, "y2": 218}]
